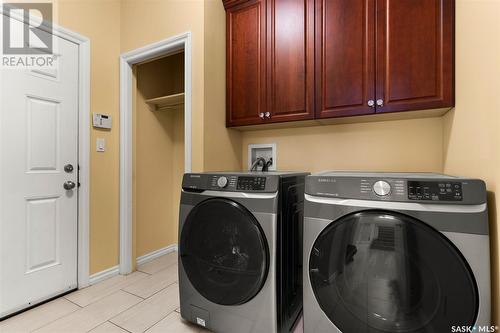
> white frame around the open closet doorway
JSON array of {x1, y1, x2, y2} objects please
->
[{"x1": 120, "y1": 32, "x2": 192, "y2": 274}]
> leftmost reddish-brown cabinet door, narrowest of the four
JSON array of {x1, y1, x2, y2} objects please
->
[{"x1": 226, "y1": 0, "x2": 266, "y2": 126}]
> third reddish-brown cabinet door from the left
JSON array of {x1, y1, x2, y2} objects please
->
[{"x1": 316, "y1": 0, "x2": 376, "y2": 118}]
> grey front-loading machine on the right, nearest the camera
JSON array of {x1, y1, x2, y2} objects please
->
[{"x1": 304, "y1": 172, "x2": 490, "y2": 333}]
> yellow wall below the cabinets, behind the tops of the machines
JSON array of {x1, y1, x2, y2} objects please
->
[{"x1": 241, "y1": 118, "x2": 443, "y2": 172}]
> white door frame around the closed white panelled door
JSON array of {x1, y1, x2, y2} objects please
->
[{"x1": 0, "y1": 6, "x2": 90, "y2": 288}]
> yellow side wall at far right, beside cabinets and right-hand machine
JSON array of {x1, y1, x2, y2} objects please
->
[{"x1": 444, "y1": 0, "x2": 500, "y2": 324}]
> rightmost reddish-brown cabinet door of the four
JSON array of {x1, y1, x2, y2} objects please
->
[{"x1": 376, "y1": 0, "x2": 454, "y2": 112}]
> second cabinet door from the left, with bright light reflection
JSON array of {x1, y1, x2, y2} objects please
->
[{"x1": 266, "y1": 0, "x2": 314, "y2": 122}]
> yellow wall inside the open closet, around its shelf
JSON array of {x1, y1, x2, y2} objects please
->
[{"x1": 133, "y1": 53, "x2": 184, "y2": 257}]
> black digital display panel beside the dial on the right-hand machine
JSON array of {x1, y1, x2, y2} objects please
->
[{"x1": 408, "y1": 181, "x2": 463, "y2": 201}]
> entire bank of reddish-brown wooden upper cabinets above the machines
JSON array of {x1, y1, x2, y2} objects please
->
[{"x1": 223, "y1": 0, "x2": 455, "y2": 126}]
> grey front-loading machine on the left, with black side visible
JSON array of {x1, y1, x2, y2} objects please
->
[{"x1": 179, "y1": 172, "x2": 306, "y2": 333}]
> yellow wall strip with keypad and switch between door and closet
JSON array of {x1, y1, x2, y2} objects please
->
[{"x1": 56, "y1": 0, "x2": 120, "y2": 274}]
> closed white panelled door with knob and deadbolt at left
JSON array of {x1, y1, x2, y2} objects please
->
[{"x1": 0, "y1": 29, "x2": 78, "y2": 318}]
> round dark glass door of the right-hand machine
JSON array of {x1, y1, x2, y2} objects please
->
[{"x1": 309, "y1": 211, "x2": 479, "y2": 333}]
